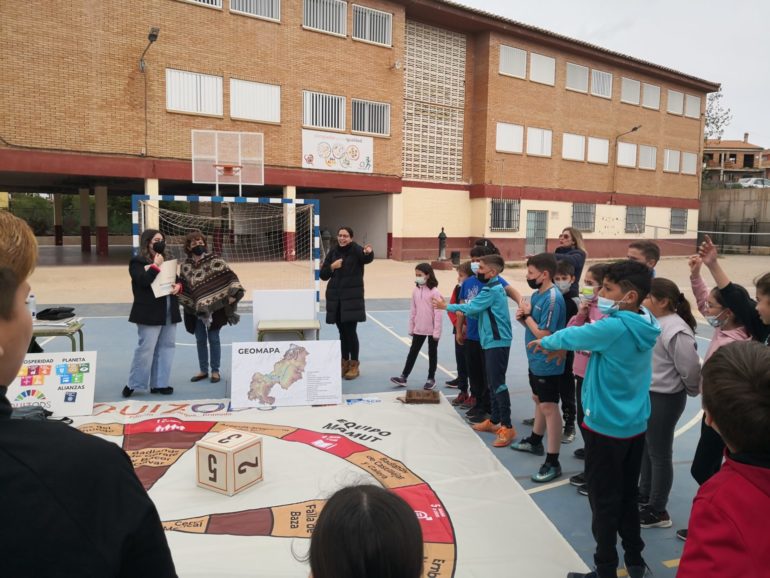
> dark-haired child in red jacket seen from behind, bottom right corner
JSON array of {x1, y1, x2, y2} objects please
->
[{"x1": 677, "y1": 341, "x2": 770, "y2": 578}]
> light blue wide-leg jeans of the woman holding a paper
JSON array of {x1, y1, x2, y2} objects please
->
[{"x1": 128, "y1": 321, "x2": 176, "y2": 391}]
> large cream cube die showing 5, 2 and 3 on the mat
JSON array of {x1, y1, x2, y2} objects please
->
[{"x1": 195, "y1": 429, "x2": 262, "y2": 496}]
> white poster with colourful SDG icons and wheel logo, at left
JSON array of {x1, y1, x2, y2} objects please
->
[{"x1": 7, "y1": 351, "x2": 96, "y2": 417}]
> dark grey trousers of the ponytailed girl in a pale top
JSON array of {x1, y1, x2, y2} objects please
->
[{"x1": 639, "y1": 390, "x2": 687, "y2": 512}]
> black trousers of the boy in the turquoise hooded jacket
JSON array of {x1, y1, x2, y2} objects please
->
[{"x1": 583, "y1": 428, "x2": 644, "y2": 578}]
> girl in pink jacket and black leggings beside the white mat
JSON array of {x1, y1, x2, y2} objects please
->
[{"x1": 390, "y1": 263, "x2": 442, "y2": 389}]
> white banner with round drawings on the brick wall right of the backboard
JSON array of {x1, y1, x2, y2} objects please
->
[{"x1": 302, "y1": 130, "x2": 374, "y2": 173}]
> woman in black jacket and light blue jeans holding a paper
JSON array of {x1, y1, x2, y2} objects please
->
[{"x1": 123, "y1": 229, "x2": 182, "y2": 397}]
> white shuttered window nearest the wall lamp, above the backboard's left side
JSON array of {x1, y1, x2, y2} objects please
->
[{"x1": 166, "y1": 68, "x2": 222, "y2": 116}]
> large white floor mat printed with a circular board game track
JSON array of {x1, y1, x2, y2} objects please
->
[{"x1": 76, "y1": 393, "x2": 585, "y2": 578}]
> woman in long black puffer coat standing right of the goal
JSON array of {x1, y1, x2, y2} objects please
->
[{"x1": 321, "y1": 227, "x2": 374, "y2": 379}]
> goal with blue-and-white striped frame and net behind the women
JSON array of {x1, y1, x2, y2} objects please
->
[{"x1": 132, "y1": 195, "x2": 320, "y2": 301}]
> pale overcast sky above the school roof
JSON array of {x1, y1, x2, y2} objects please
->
[{"x1": 454, "y1": 0, "x2": 770, "y2": 148}]
